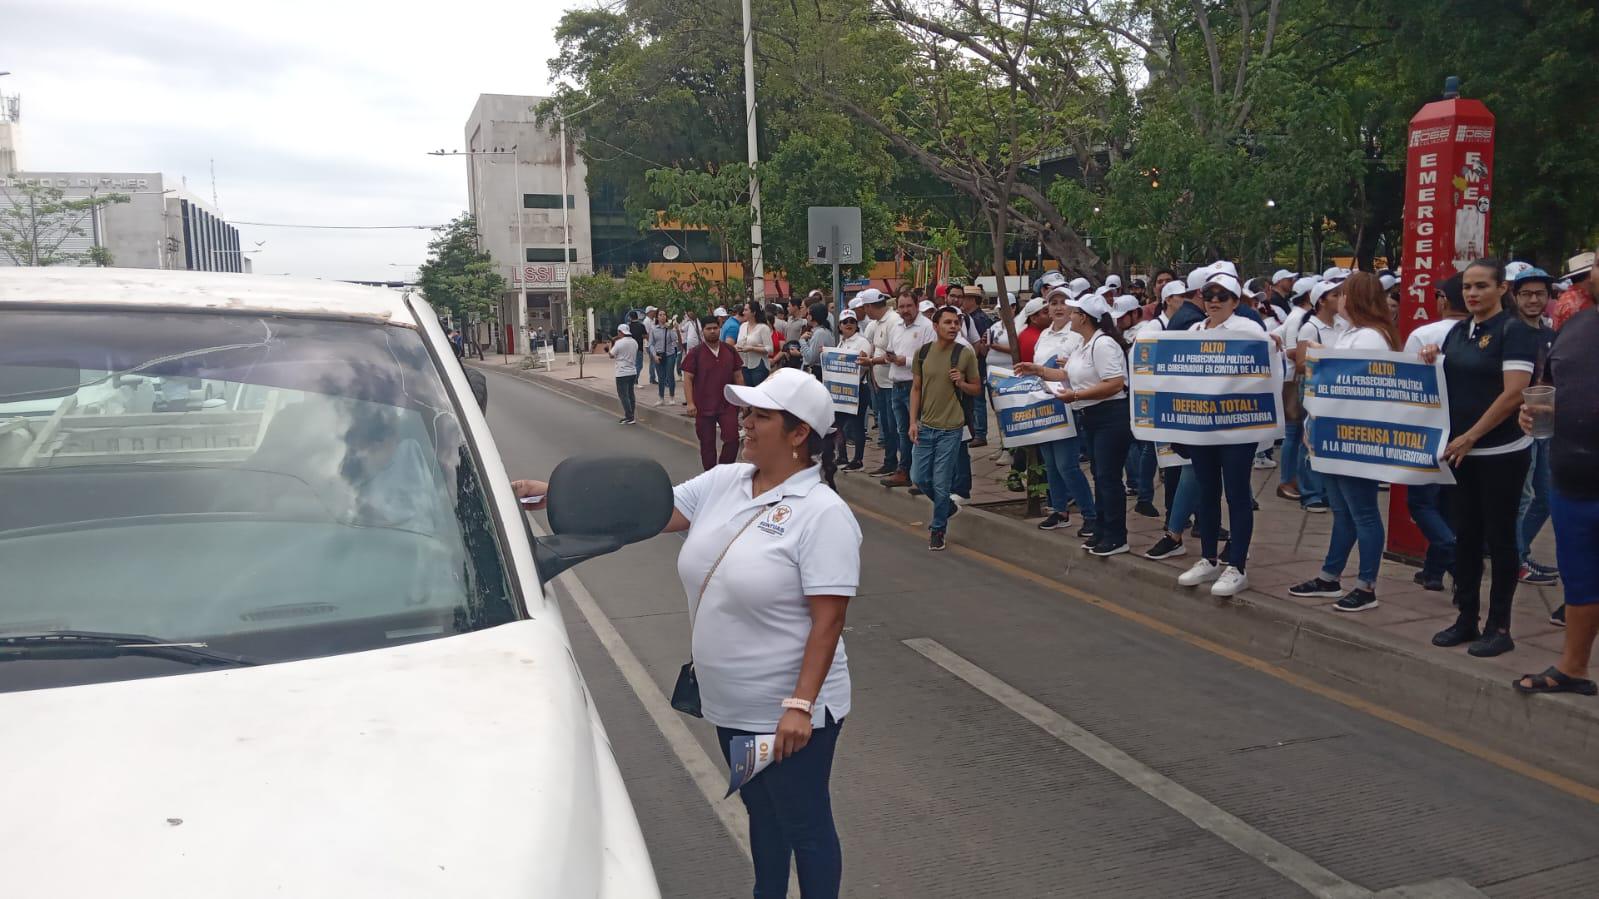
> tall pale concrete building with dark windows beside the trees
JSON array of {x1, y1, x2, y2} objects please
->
[{"x1": 465, "y1": 94, "x2": 593, "y2": 352}]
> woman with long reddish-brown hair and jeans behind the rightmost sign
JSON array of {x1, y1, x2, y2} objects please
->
[{"x1": 1289, "y1": 272, "x2": 1399, "y2": 611}]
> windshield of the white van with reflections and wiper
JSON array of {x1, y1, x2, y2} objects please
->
[{"x1": 0, "y1": 309, "x2": 516, "y2": 691}]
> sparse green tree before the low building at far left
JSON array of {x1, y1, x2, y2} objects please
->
[{"x1": 0, "y1": 184, "x2": 133, "y2": 267}]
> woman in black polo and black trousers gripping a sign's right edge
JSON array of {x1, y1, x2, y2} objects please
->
[{"x1": 1422, "y1": 259, "x2": 1538, "y2": 657}]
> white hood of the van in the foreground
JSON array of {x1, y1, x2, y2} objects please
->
[{"x1": 0, "y1": 621, "x2": 617, "y2": 897}]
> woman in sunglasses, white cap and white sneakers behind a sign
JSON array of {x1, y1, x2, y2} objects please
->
[{"x1": 1177, "y1": 272, "x2": 1266, "y2": 597}]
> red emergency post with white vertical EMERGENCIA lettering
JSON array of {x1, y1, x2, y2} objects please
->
[{"x1": 1388, "y1": 85, "x2": 1493, "y2": 558}]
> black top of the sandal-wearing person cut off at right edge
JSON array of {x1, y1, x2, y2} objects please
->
[{"x1": 1545, "y1": 306, "x2": 1599, "y2": 499}]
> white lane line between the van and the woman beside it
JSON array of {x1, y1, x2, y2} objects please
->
[{"x1": 528, "y1": 518, "x2": 801, "y2": 899}]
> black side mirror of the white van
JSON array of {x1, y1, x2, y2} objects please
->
[{"x1": 532, "y1": 456, "x2": 673, "y2": 582}]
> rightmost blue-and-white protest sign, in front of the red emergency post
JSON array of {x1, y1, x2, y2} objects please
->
[{"x1": 1305, "y1": 347, "x2": 1455, "y2": 485}]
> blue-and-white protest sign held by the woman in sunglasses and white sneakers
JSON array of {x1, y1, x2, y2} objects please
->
[{"x1": 1130, "y1": 331, "x2": 1282, "y2": 446}]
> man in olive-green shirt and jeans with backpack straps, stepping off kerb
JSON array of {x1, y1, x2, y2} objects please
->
[{"x1": 910, "y1": 306, "x2": 982, "y2": 552}]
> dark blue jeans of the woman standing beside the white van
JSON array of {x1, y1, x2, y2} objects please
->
[{"x1": 716, "y1": 712, "x2": 844, "y2": 899}]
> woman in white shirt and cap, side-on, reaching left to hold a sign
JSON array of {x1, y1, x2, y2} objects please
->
[{"x1": 1017, "y1": 294, "x2": 1132, "y2": 555}]
